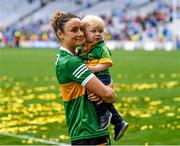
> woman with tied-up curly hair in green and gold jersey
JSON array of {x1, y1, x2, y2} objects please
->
[{"x1": 51, "y1": 11, "x2": 115, "y2": 145}]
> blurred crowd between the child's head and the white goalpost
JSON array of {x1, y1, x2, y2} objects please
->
[{"x1": 103, "y1": 2, "x2": 172, "y2": 41}]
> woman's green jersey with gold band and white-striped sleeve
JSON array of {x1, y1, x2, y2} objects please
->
[{"x1": 56, "y1": 47, "x2": 108, "y2": 141}]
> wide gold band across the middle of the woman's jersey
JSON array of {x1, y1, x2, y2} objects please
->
[{"x1": 60, "y1": 82, "x2": 85, "y2": 102}]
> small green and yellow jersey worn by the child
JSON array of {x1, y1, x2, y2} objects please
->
[{"x1": 79, "y1": 41, "x2": 112, "y2": 77}]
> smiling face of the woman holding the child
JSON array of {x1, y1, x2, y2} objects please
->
[{"x1": 61, "y1": 18, "x2": 84, "y2": 49}]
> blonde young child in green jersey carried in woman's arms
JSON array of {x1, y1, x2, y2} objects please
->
[{"x1": 79, "y1": 15, "x2": 128, "y2": 141}]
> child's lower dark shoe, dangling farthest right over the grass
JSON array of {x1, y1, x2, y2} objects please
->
[{"x1": 114, "y1": 121, "x2": 128, "y2": 141}]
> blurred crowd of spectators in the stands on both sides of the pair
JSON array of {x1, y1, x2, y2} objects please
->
[{"x1": 0, "y1": 0, "x2": 179, "y2": 47}]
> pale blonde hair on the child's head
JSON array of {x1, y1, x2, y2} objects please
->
[{"x1": 82, "y1": 15, "x2": 105, "y2": 31}]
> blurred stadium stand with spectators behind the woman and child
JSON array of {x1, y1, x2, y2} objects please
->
[{"x1": 0, "y1": 0, "x2": 180, "y2": 50}]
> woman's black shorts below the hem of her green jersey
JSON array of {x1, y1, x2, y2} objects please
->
[{"x1": 71, "y1": 135, "x2": 110, "y2": 145}]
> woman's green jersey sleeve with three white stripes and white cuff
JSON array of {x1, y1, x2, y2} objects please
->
[{"x1": 67, "y1": 56, "x2": 95, "y2": 86}]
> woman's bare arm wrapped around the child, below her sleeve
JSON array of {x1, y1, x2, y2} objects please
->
[{"x1": 85, "y1": 77, "x2": 115, "y2": 103}]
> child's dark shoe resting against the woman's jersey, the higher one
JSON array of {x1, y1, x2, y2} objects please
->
[{"x1": 99, "y1": 111, "x2": 112, "y2": 130}]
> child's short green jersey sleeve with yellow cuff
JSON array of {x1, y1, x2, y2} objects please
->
[{"x1": 98, "y1": 46, "x2": 112, "y2": 64}]
